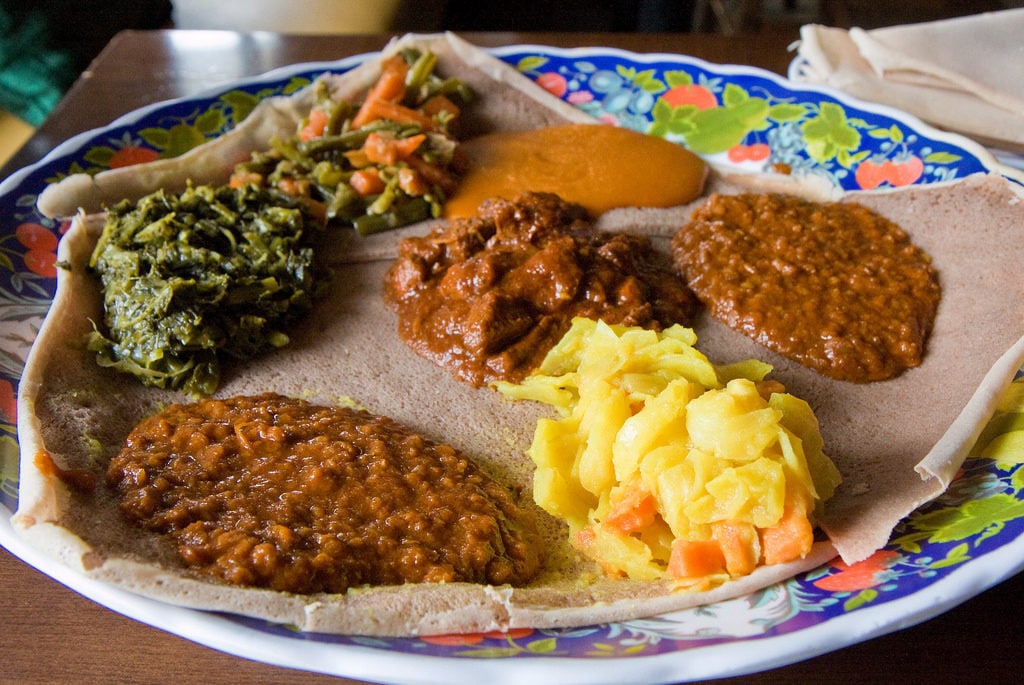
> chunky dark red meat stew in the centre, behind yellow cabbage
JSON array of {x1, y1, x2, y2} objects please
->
[{"x1": 385, "y1": 192, "x2": 698, "y2": 386}]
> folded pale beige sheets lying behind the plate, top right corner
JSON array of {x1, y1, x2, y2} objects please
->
[{"x1": 791, "y1": 8, "x2": 1024, "y2": 151}]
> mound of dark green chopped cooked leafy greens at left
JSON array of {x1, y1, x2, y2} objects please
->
[{"x1": 89, "y1": 181, "x2": 318, "y2": 395}]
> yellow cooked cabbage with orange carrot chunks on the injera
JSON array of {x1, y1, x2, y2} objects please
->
[{"x1": 497, "y1": 318, "x2": 841, "y2": 587}]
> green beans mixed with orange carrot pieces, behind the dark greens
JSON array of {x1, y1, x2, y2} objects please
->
[{"x1": 230, "y1": 49, "x2": 472, "y2": 234}]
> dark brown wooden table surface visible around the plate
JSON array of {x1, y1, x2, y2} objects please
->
[{"x1": 0, "y1": 29, "x2": 1024, "y2": 685}]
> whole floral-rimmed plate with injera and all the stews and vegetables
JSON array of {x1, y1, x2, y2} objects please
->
[{"x1": 0, "y1": 34, "x2": 1024, "y2": 683}]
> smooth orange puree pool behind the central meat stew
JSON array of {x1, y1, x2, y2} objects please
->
[{"x1": 444, "y1": 124, "x2": 707, "y2": 218}]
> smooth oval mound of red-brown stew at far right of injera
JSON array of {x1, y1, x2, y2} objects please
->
[{"x1": 672, "y1": 194, "x2": 941, "y2": 383}]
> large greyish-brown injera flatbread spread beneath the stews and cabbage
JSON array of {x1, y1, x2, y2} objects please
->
[{"x1": 13, "y1": 33, "x2": 1024, "y2": 635}]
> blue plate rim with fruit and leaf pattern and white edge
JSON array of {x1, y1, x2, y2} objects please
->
[{"x1": 0, "y1": 46, "x2": 1024, "y2": 683}]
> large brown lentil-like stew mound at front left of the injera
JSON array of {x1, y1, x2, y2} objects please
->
[{"x1": 106, "y1": 394, "x2": 543, "y2": 594}]
